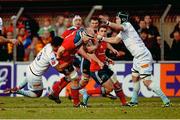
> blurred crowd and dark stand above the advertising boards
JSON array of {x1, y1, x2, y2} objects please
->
[{"x1": 0, "y1": 0, "x2": 180, "y2": 61}]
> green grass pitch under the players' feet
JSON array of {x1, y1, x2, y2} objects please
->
[{"x1": 0, "y1": 97, "x2": 180, "y2": 119}]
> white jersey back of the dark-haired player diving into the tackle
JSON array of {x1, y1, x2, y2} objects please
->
[{"x1": 30, "y1": 43, "x2": 53, "y2": 75}]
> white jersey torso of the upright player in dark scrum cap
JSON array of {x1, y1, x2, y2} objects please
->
[{"x1": 118, "y1": 22, "x2": 150, "y2": 57}]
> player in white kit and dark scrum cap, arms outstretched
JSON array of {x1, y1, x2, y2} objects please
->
[{"x1": 97, "y1": 12, "x2": 170, "y2": 107}]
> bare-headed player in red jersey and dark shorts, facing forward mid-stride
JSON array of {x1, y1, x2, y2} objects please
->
[{"x1": 80, "y1": 26, "x2": 127, "y2": 105}]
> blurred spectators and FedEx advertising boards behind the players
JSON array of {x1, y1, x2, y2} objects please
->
[{"x1": 0, "y1": 0, "x2": 180, "y2": 97}]
